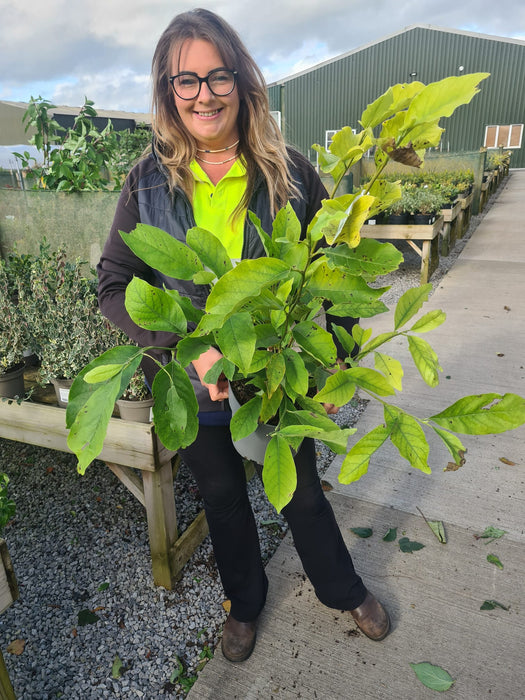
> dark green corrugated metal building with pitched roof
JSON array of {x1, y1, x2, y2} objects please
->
[{"x1": 268, "y1": 25, "x2": 525, "y2": 168}]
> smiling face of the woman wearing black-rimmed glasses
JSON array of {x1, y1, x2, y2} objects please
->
[{"x1": 171, "y1": 39, "x2": 239, "y2": 150}]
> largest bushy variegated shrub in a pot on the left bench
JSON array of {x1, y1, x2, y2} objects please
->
[{"x1": 19, "y1": 241, "x2": 126, "y2": 406}]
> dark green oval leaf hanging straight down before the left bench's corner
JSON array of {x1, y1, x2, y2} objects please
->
[{"x1": 152, "y1": 362, "x2": 199, "y2": 450}]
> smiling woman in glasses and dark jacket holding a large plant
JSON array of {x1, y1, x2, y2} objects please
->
[{"x1": 98, "y1": 10, "x2": 389, "y2": 661}]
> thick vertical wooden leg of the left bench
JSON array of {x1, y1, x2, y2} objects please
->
[{"x1": 142, "y1": 460, "x2": 178, "y2": 589}]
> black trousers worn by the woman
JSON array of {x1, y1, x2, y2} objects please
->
[{"x1": 181, "y1": 425, "x2": 366, "y2": 622}]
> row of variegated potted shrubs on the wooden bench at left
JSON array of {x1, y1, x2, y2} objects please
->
[{"x1": 0, "y1": 239, "x2": 151, "y2": 416}]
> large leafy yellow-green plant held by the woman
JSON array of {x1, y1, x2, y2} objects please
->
[{"x1": 66, "y1": 73, "x2": 525, "y2": 511}]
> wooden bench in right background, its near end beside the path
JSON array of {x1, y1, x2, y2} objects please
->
[{"x1": 361, "y1": 216, "x2": 443, "y2": 284}]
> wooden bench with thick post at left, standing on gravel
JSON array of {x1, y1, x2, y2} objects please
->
[{"x1": 0, "y1": 378, "x2": 208, "y2": 589}]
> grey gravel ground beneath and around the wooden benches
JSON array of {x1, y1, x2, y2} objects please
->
[{"x1": 0, "y1": 190, "x2": 498, "y2": 700}]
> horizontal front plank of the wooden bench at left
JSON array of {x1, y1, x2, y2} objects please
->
[{"x1": 0, "y1": 401, "x2": 162, "y2": 471}]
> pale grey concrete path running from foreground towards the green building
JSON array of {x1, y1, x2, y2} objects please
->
[{"x1": 188, "y1": 171, "x2": 525, "y2": 700}]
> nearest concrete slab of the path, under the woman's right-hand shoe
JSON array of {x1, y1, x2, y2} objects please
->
[{"x1": 188, "y1": 493, "x2": 525, "y2": 700}]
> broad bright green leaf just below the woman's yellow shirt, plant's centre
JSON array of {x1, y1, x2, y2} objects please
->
[{"x1": 206, "y1": 258, "x2": 289, "y2": 315}]
